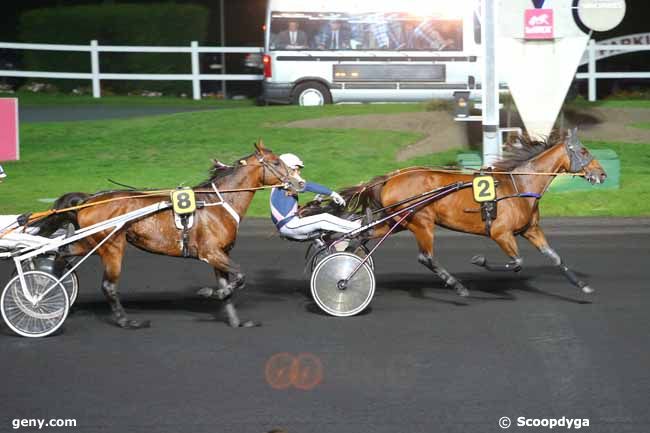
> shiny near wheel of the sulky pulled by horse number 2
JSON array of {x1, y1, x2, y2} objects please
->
[{"x1": 311, "y1": 253, "x2": 375, "y2": 317}]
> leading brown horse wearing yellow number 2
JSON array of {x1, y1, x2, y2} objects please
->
[{"x1": 340, "y1": 129, "x2": 607, "y2": 296}]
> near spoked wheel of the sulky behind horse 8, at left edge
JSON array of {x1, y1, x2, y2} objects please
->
[{"x1": 0, "y1": 271, "x2": 70, "y2": 337}]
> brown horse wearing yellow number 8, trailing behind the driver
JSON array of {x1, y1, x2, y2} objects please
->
[{"x1": 40, "y1": 140, "x2": 300, "y2": 329}]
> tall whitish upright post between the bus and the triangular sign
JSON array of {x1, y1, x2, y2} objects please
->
[{"x1": 481, "y1": 0, "x2": 501, "y2": 167}]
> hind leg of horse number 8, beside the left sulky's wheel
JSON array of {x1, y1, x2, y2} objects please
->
[{"x1": 97, "y1": 233, "x2": 151, "y2": 329}]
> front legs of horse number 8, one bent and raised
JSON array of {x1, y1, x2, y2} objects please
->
[{"x1": 197, "y1": 248, "x2": 259, "y2": 328}]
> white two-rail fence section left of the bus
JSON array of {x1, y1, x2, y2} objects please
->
[{"x1": 0, "y1": 40, "x2": 264, "y2": 99}]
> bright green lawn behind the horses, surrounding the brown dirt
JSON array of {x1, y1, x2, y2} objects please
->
[{"x1": 0, "y1": 104, "x2": 650, "y2": 216}]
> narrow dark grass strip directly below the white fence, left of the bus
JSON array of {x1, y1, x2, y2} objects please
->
[{"x1": 0, "y1": 91, "x2": 253, "y2": 107}]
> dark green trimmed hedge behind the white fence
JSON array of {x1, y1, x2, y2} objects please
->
[{"x1": 19, "y1": 3, "x2": 208, "y2": 93}]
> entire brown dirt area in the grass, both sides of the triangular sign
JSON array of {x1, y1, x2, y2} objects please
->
[{"x1": 285, "y1": 108, "x2": 650, "y2": 161}]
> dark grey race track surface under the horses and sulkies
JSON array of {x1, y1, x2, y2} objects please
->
[{"x1": 0, "y1": 219, "x2": 650, "y2": 433}]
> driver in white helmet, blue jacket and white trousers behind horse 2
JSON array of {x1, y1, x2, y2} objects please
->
[{"x1": 271, "y1": 153, "x2": 361, "y2": 240}]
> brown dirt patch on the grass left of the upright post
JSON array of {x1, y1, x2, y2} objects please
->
[{"x1": 286, "y1": 111, "x2": 468, "y2": 161}]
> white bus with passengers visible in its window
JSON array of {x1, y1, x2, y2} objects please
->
[{"x1": 262, "y1": 0, "x2": 481, "y2": 106}]
